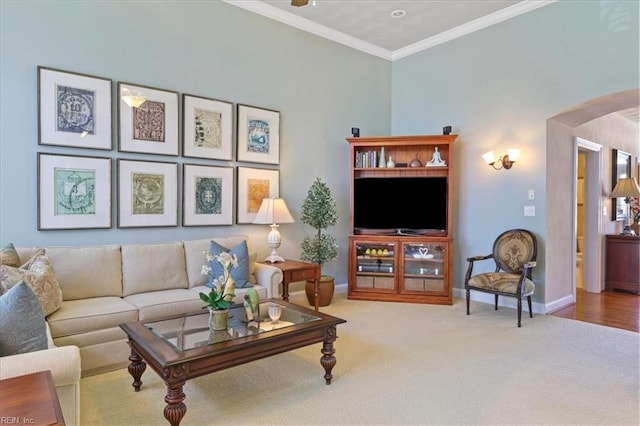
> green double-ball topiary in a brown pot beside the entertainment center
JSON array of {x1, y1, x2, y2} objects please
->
[{"x1": 300, "y1": 178, "x2": 338, "y2": 306}]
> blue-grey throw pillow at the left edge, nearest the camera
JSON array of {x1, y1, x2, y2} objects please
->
[{"x1": 0, "y1": 281, "x2": 47, "y2": 356}]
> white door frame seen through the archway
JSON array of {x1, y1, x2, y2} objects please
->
[{"x1": 573, "y1": 137, "x2": 603, "y2": 294}]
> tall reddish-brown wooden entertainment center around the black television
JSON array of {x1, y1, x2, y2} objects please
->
[{"x1": 347, "y1": 135, "x2": 457, "y2": 305}]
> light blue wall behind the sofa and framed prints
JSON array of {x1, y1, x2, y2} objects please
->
[{"x1": 0, "y1": 0, "x2": 391, "y2": 283}]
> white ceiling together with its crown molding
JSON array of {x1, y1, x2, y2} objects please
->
[{"x1": 224, "y1": 0, "x2": 640, "y2": 124}]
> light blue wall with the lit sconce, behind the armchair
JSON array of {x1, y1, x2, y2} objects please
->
[{"x1": 392, "y1": 1, "x2": 640, "y2": 301}]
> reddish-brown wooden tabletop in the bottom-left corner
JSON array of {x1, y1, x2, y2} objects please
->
[{"x1": 0, "y1": 370, "x2": 64, "y2": 426}]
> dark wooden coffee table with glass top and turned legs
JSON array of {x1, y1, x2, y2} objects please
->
[{"x1": 120, "y1": 299, "x2": 346, "y2": 425}]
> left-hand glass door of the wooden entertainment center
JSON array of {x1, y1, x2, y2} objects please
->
[{"x1": 355, "y1": 242, "x2": 396, "y2": 290}]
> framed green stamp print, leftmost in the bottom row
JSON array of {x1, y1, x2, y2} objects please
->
[{"x1": 38, "y1": 153, "x2": 111, "y2": 230}]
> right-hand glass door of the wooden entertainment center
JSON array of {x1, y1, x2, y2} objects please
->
[{"x1": 401, "y1": 243, "x2": 448, "y2": 292}]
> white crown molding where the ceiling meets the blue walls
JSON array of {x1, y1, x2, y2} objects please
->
[{"x1": 223, "y1": 0, "x2": 558, "y2": 61}]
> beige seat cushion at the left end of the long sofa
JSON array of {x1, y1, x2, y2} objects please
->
[{"x1": 47, "y1": 296, "x2": 138, "y2": 340}]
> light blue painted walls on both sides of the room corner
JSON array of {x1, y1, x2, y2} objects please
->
[{"x1": 0, "y1": 0, "x2": 640, "y2": 301}]
